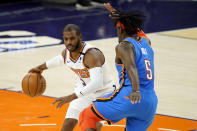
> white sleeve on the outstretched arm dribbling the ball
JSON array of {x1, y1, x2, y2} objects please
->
[{"x1": 46, "y1": 55, "x2": 64, "y2": 69}]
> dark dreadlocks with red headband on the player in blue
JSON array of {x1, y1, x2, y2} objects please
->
[{"x1": 115, "y1": 11, "x2": 145, "y2": 35}]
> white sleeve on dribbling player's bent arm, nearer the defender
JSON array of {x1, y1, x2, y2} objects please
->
[{"x1": 75, "y1": 67, "x2": 103, "y2": 97}]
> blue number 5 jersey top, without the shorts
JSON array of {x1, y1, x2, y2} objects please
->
[{"x1": 116, "y1": 38, "x2": 154, "y2": 90}]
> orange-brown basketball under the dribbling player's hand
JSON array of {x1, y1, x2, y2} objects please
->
[{"x1": 22, "y1": 73, "x2": 46, "y2": 97}]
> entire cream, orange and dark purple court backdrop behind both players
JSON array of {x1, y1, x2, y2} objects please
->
[{"x1": 0, "y1": 0, "x2": 197, "y2": 131}]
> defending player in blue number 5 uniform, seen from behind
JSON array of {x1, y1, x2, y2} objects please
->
[{"x1": 79, "y1": 4, "x2": 157, "y2": 131}]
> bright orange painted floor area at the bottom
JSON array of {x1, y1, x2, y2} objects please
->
[{"x1": 0, "y1": 90, "x2": 197, "y2": 131}]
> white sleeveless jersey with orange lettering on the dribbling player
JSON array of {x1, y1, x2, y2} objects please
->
[{"x1": 64, "y1": 43, "x2": 114, "y2": 97}]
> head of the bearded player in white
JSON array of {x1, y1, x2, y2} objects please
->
[{"x1": 63, "y1": 24, "x2": 82, "y2": 52}]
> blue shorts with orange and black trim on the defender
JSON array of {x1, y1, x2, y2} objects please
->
[{"x1": 93, "y1": 86, "x2": 158, "y2": 131}]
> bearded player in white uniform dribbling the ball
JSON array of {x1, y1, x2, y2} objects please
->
[{"x1": 29, "y1": 24, "x2": 115, "y2": 131}]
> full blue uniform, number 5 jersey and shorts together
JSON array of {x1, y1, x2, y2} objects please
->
[{"x1": 92, "y1": 38, "x2": 158, "y2": 131}]
